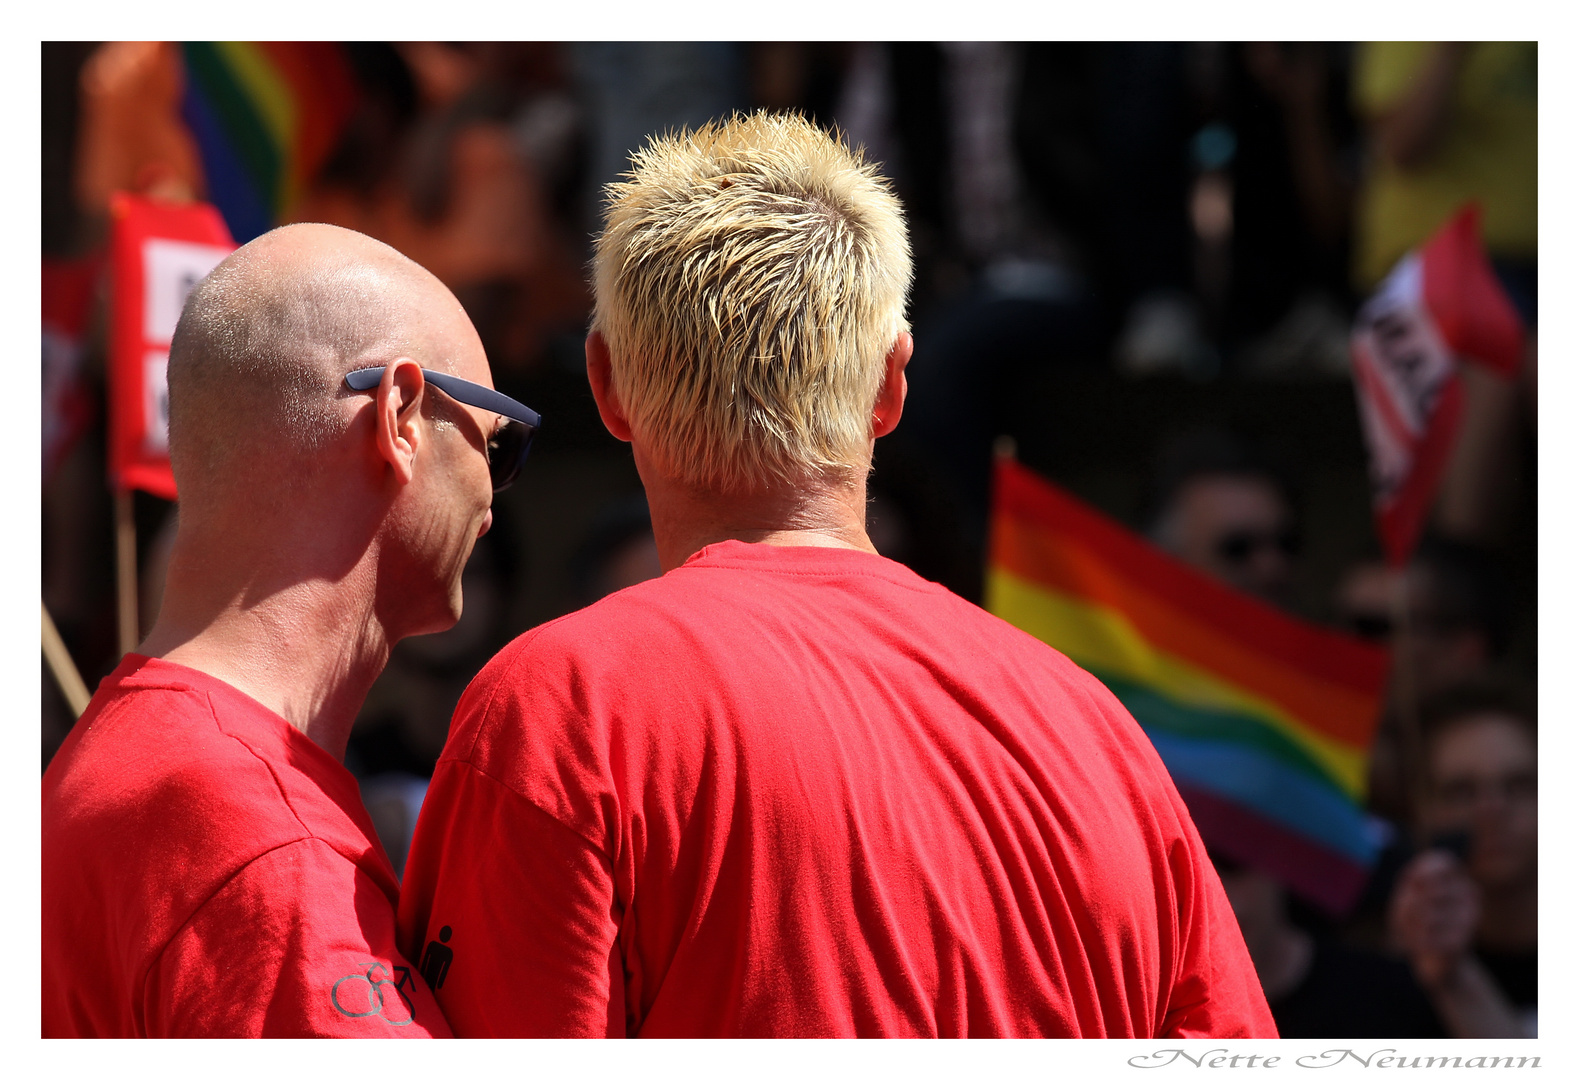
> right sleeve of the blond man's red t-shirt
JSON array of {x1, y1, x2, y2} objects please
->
[{"x1": 1159, "y1": 821, "x2": 1277, "y2": 1039}]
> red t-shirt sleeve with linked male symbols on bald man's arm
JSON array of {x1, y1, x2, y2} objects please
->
[{"x1": 142, "y1": 838, "x2": 450, "y2": 1039}]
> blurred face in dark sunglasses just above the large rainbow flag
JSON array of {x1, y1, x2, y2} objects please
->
[{"x1": 1162, "y1": 474, "x2": 1298, "y2": 603}]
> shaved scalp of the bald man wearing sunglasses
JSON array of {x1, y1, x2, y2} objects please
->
[{"x1": 169, "y1": 224, "x2": 475, "y2": 502}]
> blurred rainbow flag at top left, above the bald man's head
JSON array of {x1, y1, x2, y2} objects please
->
[{"x1": 182, "y1": 41, "x2": 357, "y2": 243}]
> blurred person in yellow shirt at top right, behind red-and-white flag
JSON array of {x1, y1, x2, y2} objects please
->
[{"x1": 1353, "y1": 41, "x2": 1540, "y2": 546}]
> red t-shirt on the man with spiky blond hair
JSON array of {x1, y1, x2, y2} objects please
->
[{"x1": 399, "y1": 542, "x2": 1276, "y2": 1037}]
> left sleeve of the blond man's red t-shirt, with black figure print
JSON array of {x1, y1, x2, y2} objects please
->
[{"x1": 401, "y1": 761, "x2": 625, "y2": 1037}]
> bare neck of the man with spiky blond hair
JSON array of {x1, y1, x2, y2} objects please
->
[{"x1": 636, "y1": 455, "x2": 876, "y2": 570}]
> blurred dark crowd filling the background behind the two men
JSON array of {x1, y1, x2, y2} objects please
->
[{"x1": 43, "y1": 43, "x2": 1538, "y2": 1037}]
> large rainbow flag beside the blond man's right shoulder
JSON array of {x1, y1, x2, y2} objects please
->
[{"x1": 987, "y1": 461, "x2": 1388, "y2": 913}]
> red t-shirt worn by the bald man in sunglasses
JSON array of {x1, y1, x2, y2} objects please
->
[{"x1": 43, "y1": 654, "x2": 450, "y2": 1037}]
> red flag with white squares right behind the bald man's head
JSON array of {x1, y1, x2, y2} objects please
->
[{"x1": 109, "y1": 191, "x2": 235, "y2": 499}]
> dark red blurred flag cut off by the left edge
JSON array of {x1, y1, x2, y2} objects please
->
[{"x1": 39, "y1": 256, "x2": 103, "y2": 483}]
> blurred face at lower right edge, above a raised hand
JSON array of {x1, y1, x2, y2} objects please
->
[{"x1": 1426, "y1": 712, "x2": 1536, "y2": 889}]
